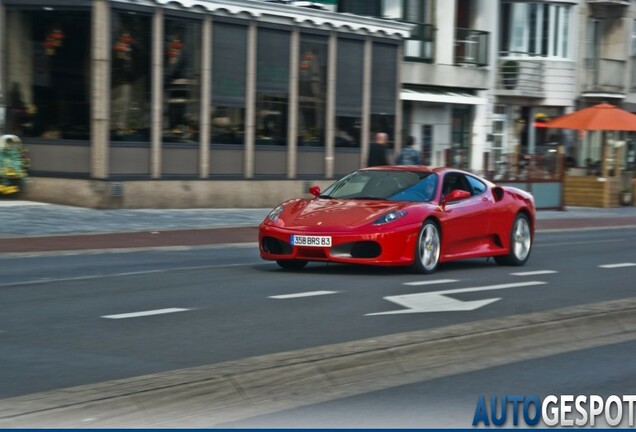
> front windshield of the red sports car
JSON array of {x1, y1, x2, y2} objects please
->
[{"x1": 320, "y1": 170, "x2": 437, "y2": 202}]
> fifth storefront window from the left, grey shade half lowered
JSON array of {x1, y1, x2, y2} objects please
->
[{"x1": 256, "y1": 28, "x2": 290, "y2": 145}]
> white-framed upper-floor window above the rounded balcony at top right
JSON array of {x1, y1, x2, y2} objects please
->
[{"x1": 500, "y1": 0, "x2": 572, "y2": 58}]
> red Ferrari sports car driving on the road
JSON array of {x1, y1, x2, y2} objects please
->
[{"x1": 259, "y1": 166, "x2": 535, "y2": 273}]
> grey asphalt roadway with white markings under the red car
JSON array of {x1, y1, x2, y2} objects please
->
[{"x1": 0, "y1": 229, "x2": 636, "y2": 397}]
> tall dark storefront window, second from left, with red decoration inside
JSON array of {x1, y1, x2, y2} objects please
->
[{"x1": 111, "y1": 11, "x2": 152, "y2": 141}]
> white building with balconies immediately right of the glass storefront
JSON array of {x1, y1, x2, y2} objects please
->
[{"x1": 338, "y1": 0, "x2": 497, "y2": 169}]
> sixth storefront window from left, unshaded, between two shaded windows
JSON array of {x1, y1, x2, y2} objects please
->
[{"x1": 298, "y1": 34, "x2": 328, "y2": 146}]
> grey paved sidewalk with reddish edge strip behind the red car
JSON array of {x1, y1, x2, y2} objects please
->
[{"x1": 0, "y1": 200, "x2": 636, "y2": 253}]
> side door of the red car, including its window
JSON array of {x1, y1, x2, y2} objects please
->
[{"x1": 442, "y1": 171, "x2": 494, "y2": 257}]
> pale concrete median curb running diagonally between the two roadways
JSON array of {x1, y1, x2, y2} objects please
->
[{"x1": 0, "y1": 297, "x2": 636, "y2": 428}]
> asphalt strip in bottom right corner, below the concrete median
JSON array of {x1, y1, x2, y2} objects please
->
[{"x1": 221, "y1": 341, "x2": 636, "y2": 429}]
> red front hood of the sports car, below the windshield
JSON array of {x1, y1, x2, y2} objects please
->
[{"x1": 281, "y1": 199, "x2": 408, "y2": 228}]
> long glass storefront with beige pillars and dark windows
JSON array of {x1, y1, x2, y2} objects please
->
[{"x1": 2, "y1": 0, "x2": 399, "y2": 180}]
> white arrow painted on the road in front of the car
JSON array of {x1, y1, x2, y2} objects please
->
[{"x1": 365, "y1": 281, "x2": 547, "y2": 316}]
